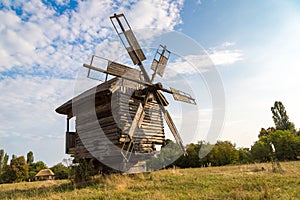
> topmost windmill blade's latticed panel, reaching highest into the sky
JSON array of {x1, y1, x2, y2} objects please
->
[{"x1": 110, "y1": 14, "x2": 146, "y2": 65}]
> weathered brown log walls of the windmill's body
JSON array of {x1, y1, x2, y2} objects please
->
[{"x1": 58, "y1": 79, "x2": 165, "y2": 166}]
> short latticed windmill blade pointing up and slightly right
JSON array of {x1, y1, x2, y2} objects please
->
[{"x1": 151, "y1": 45, "x2": 171, "y2": 83}]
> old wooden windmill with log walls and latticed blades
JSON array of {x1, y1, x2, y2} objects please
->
[{"x1": 56, "y1": 14, "x2": 196, "y2": 170}]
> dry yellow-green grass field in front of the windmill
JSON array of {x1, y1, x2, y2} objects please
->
[{"x1": 0, "y1": 162, "x2": 300, "y2": 200}]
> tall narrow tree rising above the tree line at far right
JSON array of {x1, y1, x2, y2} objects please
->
[{"x1": 271, "y1": 101, "x2": 296, "y2": 133}]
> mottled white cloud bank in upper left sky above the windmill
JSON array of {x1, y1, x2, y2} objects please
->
[{"x1": 0, "y1": 0, "x2": 183, "y2": 76}]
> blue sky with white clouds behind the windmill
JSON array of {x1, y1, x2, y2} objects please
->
[{"x1": 0, "y1": 0, "x2": 300, "y2": 166}]
